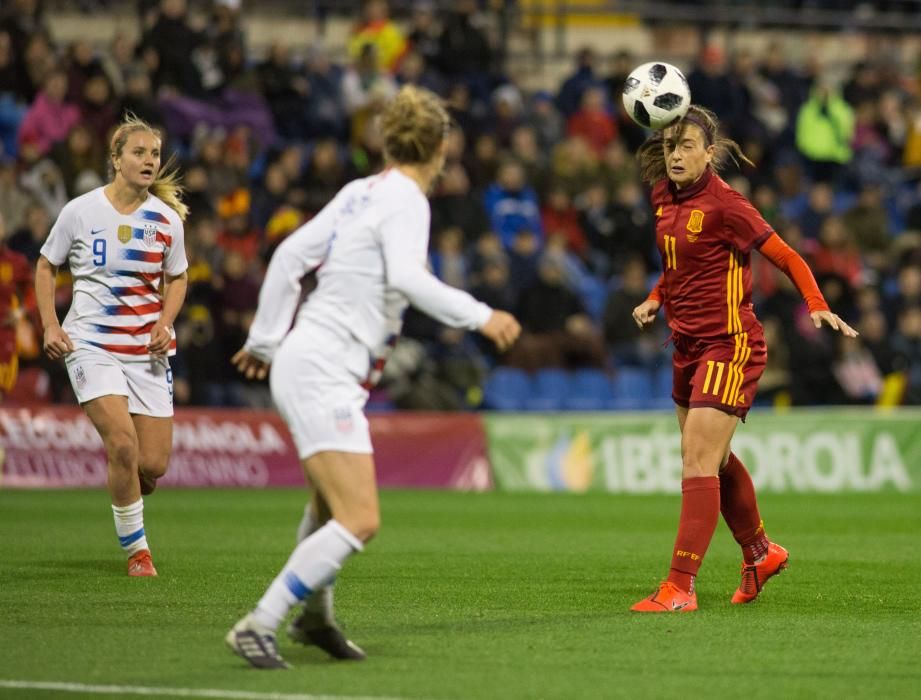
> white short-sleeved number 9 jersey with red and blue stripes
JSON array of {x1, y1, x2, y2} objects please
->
[{"x1": 41, "y1": 187, "x2": 189, "y2": 360}]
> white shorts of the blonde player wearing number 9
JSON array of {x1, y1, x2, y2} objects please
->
[{"x1": 64, "y1": 345, "x2": 173, "y2": 418}]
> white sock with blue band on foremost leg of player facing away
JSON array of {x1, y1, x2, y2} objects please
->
[{"x1": 253, "y1": 520, "x2": 364, "y2": 630}]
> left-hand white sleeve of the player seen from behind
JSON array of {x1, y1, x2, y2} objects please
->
[{"x1": 243, "y1": 199, "x2": 336, "y2": 362}]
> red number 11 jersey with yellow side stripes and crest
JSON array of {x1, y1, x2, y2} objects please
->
[{"x1": 652, "y1": 168, "x2": 774, "y2": 338}]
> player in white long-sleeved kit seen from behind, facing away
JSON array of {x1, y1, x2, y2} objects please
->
[{"x1": 226, "y1": 87, "x2": 521, "y2": 668}]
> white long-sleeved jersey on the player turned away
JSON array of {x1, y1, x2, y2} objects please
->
[{"x1": 246, "y1": 169, "x2": 492, "y2": 385}]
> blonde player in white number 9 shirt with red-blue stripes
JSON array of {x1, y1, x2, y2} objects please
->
[{"x1": 35, "y1": 117, "x2": 188, "y2": 576}]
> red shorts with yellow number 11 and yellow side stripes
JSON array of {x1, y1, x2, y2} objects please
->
[{"x1": 672, "y1": 324, "x2": 767, "y2": 420}]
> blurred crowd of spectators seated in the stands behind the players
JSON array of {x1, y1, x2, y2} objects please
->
[{"x1": 0, "y1": 0, "x2": 921, "y2": 410}]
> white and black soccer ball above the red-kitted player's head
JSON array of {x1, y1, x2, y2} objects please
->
[{"x1": 623, "y1": 61, "x2": 691, "y2": 129}]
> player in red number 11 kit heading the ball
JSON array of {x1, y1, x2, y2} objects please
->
[{"x1": 632, "y1": 105, "x2": 857, "y2": 612}]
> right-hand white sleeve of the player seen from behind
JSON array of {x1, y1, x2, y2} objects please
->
[{"x1": 379, "y1": 200, "x2": 492, "y2": 330}]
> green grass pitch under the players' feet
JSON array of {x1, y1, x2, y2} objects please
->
[{"x1": 0, "y1": 490, "x2": 921, "y2": 700}]
